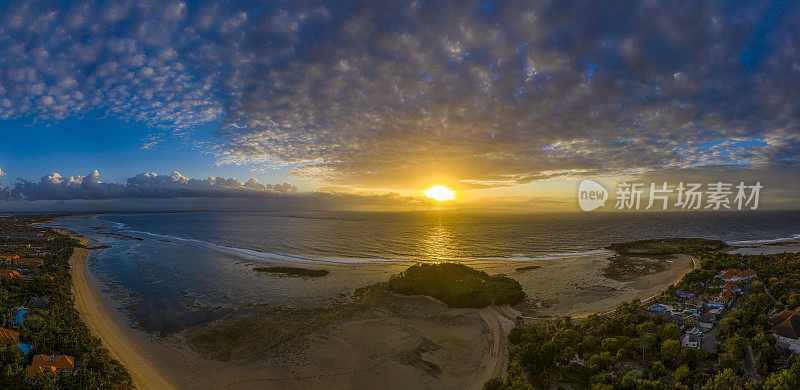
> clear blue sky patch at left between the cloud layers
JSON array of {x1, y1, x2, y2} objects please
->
[{"x1": 0, "y1": 116, "x2": 297, "y2": 187}]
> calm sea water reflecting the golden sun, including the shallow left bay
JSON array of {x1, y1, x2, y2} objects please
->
[{"x1": 47, "y1": 211, "x2": 800, "y2": 332}]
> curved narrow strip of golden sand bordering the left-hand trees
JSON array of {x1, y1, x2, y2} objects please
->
[{"x1": 69, "y1": 236, "x2": 175, "y2": 390}]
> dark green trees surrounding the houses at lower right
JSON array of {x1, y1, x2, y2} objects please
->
[{"x1": 484, "y1": 239, "x2": 800, "y2": 390}]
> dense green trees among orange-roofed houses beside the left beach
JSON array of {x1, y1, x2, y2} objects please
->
[{"x1": 0, "y1": 216, "x2": 132, "y2": 389}]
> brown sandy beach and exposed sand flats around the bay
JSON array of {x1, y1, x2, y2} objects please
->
[{"x1": 70, "y1": 230, "x2": 693, "y2": 389}]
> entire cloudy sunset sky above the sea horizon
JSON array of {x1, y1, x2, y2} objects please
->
[{"x1": 0, "y1": 0, "x2": 800, "y2": 210}]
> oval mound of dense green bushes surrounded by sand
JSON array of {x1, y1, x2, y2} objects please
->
[{"x1": 389, "y1": 263, "x2": 525, "y2": 308}]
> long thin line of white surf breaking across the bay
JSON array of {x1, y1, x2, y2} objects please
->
[{"x1": 115, "y1": 230, "x2": 611, "y2": 264}]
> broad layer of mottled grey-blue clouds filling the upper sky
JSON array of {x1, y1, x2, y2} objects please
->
[{"x1": 0, "y1": 0, "x2": 800, "y2": 189}]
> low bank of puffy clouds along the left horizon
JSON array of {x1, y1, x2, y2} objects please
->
[{"x1": 0, "y1": 170, "x2": 297, "y2": 201}]
